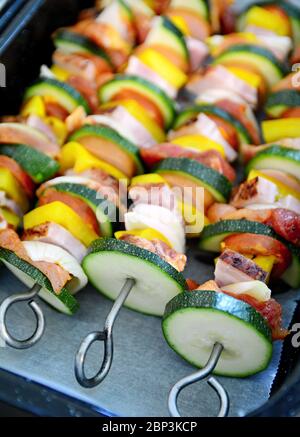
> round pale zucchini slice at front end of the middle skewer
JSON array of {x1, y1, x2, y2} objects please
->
[{"x1": 82, "y1": 238, "x2": 186, "y2": 316}]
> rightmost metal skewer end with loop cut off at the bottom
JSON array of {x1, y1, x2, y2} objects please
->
[{"x1": 168, "y1": 343, "x2": 229, "y2": 417}]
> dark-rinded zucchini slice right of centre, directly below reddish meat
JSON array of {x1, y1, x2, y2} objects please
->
[{"x1": 155, "y1": 158, "x2": 232, "y2": 202}]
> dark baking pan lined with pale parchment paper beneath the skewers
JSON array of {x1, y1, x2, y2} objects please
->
[{"x1": 0, "y1": 0, "x2": 300, "y2": 416}]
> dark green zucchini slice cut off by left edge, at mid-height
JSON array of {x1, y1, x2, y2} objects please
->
[{"x1": 0, "y1": 144, "x2": 59, "y2": 184}]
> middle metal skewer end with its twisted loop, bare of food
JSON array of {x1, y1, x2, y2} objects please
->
[{"x1": 75, "y1": 278, "x2": 135, "y2": 388}]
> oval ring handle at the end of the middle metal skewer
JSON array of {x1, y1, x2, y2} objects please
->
[{"x1": 75, "y1": 331, "x2": 113, "y2": 388}]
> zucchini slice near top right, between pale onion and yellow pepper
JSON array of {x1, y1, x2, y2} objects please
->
[{"x1": 213, "y1": 44, "x2": 288, "y2": 88}]
